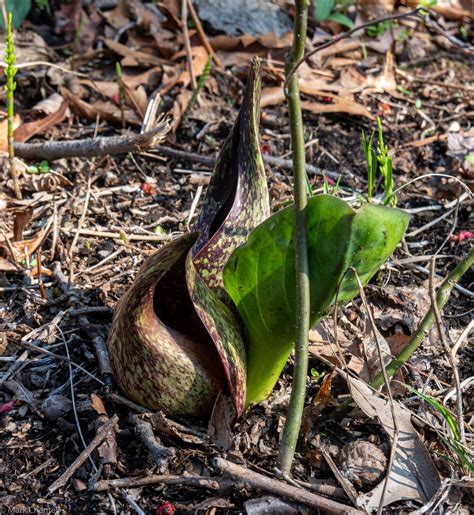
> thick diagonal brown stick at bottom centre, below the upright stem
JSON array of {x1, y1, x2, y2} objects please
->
[{"x1": 212, "y1": 458, "x2": 363, "y2": 515}]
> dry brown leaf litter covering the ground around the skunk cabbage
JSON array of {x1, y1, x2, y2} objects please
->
[{"x1": 0, "y1": 1, "x2": 472, "y2": 512}]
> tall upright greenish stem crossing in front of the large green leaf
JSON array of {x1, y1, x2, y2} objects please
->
[{"x1": 279, "y1": 0, "x2": 310, "y2": 475}]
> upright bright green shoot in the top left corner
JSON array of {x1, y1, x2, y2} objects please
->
[{"x1": 5, "y1": 13, "x2": 22, "y2": 200}]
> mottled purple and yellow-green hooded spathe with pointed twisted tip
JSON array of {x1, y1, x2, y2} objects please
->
[{"x1": 108, "y1": 59, "x2": 270, "y2": 418}]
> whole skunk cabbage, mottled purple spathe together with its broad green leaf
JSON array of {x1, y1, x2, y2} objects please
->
[{"x1": 108, "y1": 59, "x2": 408, "y2": 418}]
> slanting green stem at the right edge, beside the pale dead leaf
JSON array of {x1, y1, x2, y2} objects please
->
[{"x1": 370, "y1": 247, "x2": 474, "y2": 389}]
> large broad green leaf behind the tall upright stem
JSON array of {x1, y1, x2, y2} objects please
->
[{"x1": 224, "y1": 195, "x2": 409, "y2": 405}]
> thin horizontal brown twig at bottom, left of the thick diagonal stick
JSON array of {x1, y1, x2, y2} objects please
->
[{"x1": 94, "y1": 474, "x2": 222, "y2": 492}]
